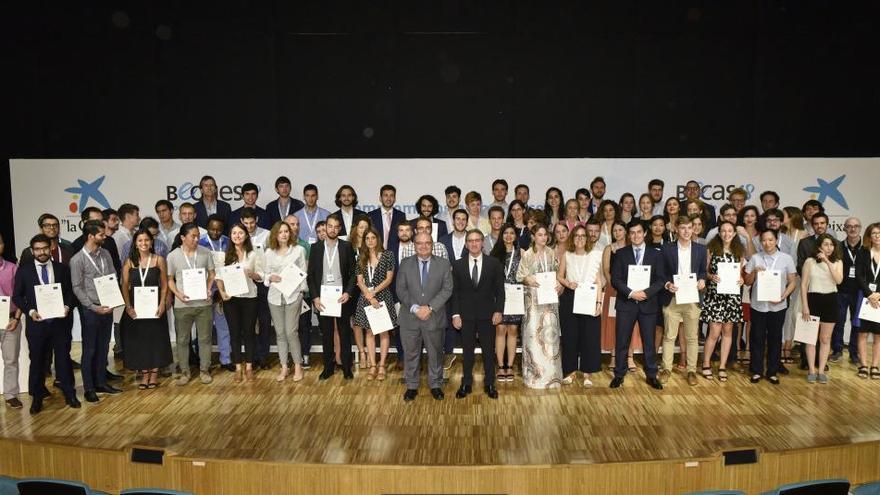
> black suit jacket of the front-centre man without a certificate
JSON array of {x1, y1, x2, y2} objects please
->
[{"x1": 452, "y1": 254, "x2": 504, "y2": 320}]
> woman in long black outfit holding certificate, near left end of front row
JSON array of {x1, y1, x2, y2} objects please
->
[{"x1": 120, "y1": 229, "x2": 172, "y2": 390}]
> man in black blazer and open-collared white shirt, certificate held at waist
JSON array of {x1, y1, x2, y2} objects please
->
[{"x1": 307, "y1": 215, "x2": 358, "y2": 380}]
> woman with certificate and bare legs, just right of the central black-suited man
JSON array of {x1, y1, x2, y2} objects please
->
[{"x1": 490, "y1": 223, "x2": 524, "y2": 382}]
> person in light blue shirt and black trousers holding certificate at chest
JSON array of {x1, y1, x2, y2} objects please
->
[{"x1": 745, "y1": 230, "x2": 797, "y2": 385}]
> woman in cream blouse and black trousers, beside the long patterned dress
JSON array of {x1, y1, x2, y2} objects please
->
[{"x1": 557, "y1": 225, "x2": 602, "y2": 387}]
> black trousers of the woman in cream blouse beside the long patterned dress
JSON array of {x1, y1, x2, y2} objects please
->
[{"x1": 559, "y1": 289, "x2": 602, "y2": 376}]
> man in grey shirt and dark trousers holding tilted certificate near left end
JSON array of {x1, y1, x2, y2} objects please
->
[{"x1": 70, "y1": 220, "x2": 124, "y2": 402}]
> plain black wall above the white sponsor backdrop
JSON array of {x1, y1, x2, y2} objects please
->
[{"x1": 0, "y1": 0, "x2": 880, "y2": 251}]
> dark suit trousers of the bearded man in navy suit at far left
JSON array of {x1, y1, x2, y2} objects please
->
[{"x1": 25, "y1": 319, "x2": 76, "y2": 397}]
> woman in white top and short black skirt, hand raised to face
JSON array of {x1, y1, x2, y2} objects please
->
[{"x1": 801, "y1": 234, "x2": 843, "y2": 384}]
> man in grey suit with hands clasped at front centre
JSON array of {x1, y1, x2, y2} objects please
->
[{"x1": 397, "y1": 233, "x2": 452, "y2": 402}]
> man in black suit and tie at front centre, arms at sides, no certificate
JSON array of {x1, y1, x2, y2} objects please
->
[{"x1": 452, "y1": 229, "x2": 504, "y2": 399}]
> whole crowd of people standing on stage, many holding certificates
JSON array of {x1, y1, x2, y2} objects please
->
[{"x1": 0, "y1": 176, "x2": 880, "y2": 414}]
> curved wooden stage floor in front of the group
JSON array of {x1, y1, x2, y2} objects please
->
[{"x1": 0, "y1": 346, "x2": 880, "y2": 494}]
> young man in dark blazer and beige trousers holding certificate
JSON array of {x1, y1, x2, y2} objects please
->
[{"x1": 660, "y1": 215, "x2": 707, "y2": 386}]
